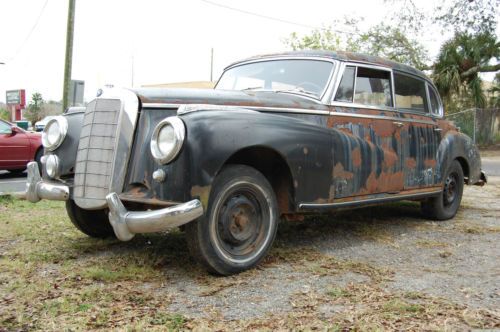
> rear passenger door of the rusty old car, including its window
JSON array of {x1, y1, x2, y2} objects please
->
[{"x1": 394, "y1": 71, "x2": 441, "y2": 190}]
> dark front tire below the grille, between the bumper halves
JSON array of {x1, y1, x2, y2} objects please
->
[{"x1": 66, "y1": 199, "x2": 116, "y2": 238}]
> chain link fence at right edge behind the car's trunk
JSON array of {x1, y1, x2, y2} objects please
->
[{"x1": 446, "y1": 108, "x2": 500, "y2": 146}]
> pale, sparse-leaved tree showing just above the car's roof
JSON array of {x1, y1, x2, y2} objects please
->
[{"x1": 284, "y1": 21, "x2": 429, "y2": 69}]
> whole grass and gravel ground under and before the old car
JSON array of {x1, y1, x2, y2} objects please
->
[{"x1": 0, "y1": 177, "x2": 500, "y2": 330}]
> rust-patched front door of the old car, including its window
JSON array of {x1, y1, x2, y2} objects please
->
[{"x1": 329, "y1": 64, "x2": 407, "y2": 198}]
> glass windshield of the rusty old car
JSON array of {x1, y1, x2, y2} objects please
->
[{"x1": 215, "y1": 59, "x2": 333, "y2": 99}]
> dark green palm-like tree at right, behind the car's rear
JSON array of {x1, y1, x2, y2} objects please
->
[{"x1": 432, "y1": 32, "x2": 500, "y2": 107}]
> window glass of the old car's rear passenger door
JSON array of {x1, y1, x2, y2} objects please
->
[{"x1": 394, "y1": 73, "x2": 429, "y2": 113}]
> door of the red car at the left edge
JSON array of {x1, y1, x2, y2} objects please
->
[{"x1": 0, "y1": 121, "x2": 30, "y2": 169}]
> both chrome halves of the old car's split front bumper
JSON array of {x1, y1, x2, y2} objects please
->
[{"x1": 26, "y1": 162, "x2": 203, "y2": 241}]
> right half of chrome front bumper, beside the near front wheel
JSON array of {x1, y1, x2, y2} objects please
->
[{"x1": 106, "y1": 193, "x2": 203, "y2": 241}]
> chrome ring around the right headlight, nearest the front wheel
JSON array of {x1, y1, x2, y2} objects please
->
[{"x1": 150, "y1": 116, "x2": 186, "y2": 165}]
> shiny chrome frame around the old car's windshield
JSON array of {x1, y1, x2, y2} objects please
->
[{"x1": 214, "y1": 56, "x2": 339, "y2": 104}]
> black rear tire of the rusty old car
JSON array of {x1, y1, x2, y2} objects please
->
[{"x1": 421, "y1": 160, "x2": 464, "y2": 220}]
